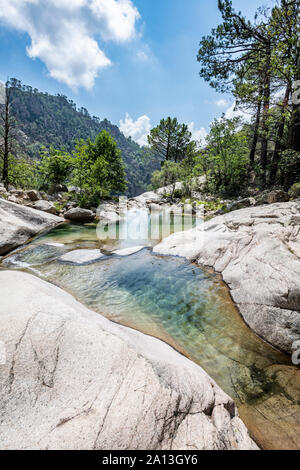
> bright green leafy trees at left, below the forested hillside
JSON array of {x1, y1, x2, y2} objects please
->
[{"x1": 0, "y1": 131, "x2": 126, "y2": 210}]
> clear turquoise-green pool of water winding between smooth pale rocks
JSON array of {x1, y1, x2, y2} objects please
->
[{"x1": 2, "y1": 217, "x2": 300, "y2": 448}]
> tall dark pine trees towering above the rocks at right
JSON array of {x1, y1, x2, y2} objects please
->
[{"x1": 198, "y1": 0, "x2": 300, "y2": 189}]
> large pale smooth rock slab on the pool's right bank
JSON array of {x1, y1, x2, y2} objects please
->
[{"x1": 154, "y1": 201, "x2": 300, "y2": 353}]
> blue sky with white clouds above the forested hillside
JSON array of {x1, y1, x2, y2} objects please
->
[{"x1": 0, "y1": 0, "x2": 272, "y2": 142}]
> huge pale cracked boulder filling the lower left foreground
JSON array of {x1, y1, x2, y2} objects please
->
[{"x1": 0, "y1": 271, "x2": 257, "y2": 451}]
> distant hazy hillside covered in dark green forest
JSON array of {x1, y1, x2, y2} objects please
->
[{"x1": 6, "y1": 79, "x2": 160, "y2": 196}]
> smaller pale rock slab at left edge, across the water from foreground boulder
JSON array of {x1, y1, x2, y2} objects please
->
[{"x1": 0, "y1": 199, "x2": 63, "y2": 255}]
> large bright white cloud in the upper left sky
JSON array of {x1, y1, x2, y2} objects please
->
[{"x1": 0, "y1": 0, "x2": 140, "y2": 88}]
